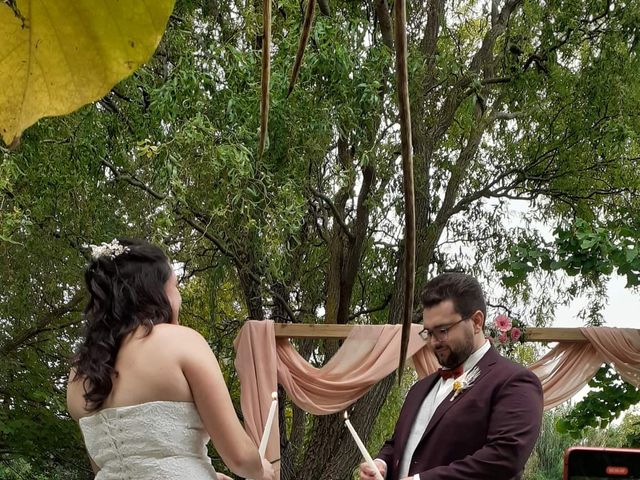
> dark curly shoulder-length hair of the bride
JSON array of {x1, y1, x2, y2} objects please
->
[{"x1": 72, "y1": 239, "x2": 172, "y2": 411}]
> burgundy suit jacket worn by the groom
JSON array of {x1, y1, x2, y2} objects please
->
[{"x1": 378, "y1": 348, "x2": 543, "y2": 480}]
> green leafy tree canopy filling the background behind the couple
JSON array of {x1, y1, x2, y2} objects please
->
[{"x1": 0, "y1": 0, "x2": 640, "y2": 480}]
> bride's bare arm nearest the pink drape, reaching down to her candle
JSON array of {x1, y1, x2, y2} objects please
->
[{"x1": 174, "y1": 327, "x2": 273, "y2": 480}]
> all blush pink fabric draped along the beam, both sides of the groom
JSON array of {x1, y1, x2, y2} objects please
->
[{"x1": 234, "y1": 320, "x2": 640, "y2": 478}]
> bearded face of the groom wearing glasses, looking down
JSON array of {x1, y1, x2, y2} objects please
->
[{"x1": 422, "y1": 300, "x2": 474, "y2": 368}]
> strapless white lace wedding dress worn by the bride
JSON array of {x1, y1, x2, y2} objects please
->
[{"x1": 80, "y1": 402, "x2": 217, "y2": 480}]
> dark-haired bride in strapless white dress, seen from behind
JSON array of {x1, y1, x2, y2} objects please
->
[{"x1": 67, "y1": 240, "x2": 275, "y2": 480}]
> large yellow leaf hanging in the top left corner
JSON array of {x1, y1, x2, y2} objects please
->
[{"x1": 0, "y1": 0, "x2": 175, "y2": 144}]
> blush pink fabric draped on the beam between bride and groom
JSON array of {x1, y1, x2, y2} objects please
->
[{"x1": 234, "y1": 320, "x2": 440, "y2": 476}]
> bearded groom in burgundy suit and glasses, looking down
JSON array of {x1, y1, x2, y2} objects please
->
[{"x1": 360, "y1": 273, "x2": 542, "y2": 480}]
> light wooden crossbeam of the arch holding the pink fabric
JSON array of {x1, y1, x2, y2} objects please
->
[{"x1": 275, "y1": 323, "x2": 587, "y2": 342}]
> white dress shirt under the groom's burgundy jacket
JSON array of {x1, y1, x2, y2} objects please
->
[{"x1": 398, "y1": 341, "x2": 491, "y2": 480}]
